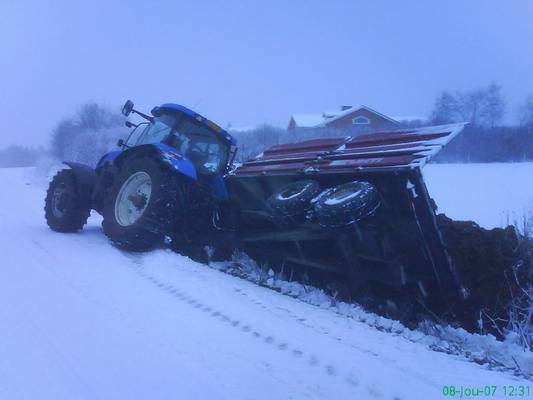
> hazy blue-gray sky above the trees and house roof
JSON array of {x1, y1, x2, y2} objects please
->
[{"x1": 0, "y1": 0, "x2": 533, "y2": 148}]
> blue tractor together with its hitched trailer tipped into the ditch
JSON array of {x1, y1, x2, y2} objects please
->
[{"x1": 45, "y1": 101, "x2": 466, "y2": 318}]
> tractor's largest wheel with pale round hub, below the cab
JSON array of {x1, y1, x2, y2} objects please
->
[{"x1": 102, "y1": 158, "x2": 180, "y2": 251}]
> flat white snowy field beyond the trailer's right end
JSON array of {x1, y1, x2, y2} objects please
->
[{"x1": 423, "y1": 162, "x2": 533, "y2": 228}]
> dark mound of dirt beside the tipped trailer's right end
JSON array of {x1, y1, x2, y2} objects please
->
[{"x1": 437, "y1": 214, "x2": 531, "y2": 336}]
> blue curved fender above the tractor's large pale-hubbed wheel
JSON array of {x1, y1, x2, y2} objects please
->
[{"x1": 107, "y1": 143, "x2": 198, "y2": 181}]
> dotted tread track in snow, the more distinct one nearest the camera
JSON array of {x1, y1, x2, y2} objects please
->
[{"x1": 133, "y1": 259, "x2": 401, "y2": 400}]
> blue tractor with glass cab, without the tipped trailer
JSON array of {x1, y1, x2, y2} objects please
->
[{"x1": 45, "y1": 100, "x2": 237, "y2": 252}]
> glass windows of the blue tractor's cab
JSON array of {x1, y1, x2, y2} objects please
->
[{"x1": 136, "y1": 115, "x2": 228, "y2": 174}]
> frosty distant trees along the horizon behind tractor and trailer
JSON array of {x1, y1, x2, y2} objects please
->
[{"x1": 0, "y1": 83, "x2": 533, "y2": 167}]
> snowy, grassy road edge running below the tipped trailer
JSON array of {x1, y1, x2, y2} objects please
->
[{"x1": 210, "y1": 254, "x2": 533, "y2": 379}]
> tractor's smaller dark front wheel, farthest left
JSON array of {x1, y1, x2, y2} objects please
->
[{"x1": 44, "y1": 169, "x2": 91, "y2": 232}]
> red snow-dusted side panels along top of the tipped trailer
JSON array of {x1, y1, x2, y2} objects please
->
[{"x1": 234, "y1": 123, "x2": 466, "y2": 175}]
